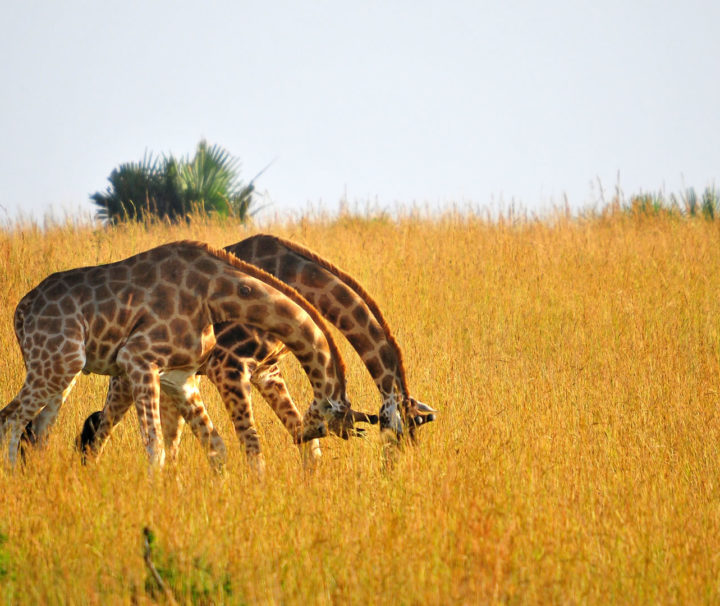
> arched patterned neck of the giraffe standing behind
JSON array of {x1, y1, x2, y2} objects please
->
[{"x1": 225, "y1": 234, "x2": 408, "y2": 402}]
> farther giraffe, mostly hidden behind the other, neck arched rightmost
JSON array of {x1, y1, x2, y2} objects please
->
[{"x1": 79, "y1": 234, "x2": 436, "y2": 467}]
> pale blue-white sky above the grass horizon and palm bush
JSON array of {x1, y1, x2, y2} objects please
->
[{"x1": 0, "y1": 0, "x2": 720, "y2": 221}]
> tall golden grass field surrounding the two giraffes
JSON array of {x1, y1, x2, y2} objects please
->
[{"x1": 0, "y1": 212, "x2": 720, "y2": 604}]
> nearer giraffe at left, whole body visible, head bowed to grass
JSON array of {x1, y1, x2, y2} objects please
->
[{"x1": 0, "y1": 241, "x2": 366, "y2": 465}]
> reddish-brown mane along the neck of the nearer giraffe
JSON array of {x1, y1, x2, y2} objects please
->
[{"x1": 175, "y1": 240, "x2": 347, "y2": 391}]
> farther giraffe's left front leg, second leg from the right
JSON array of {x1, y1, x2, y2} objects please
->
[{"x1": 207, "y1": 358, "x2": 265, "y2": 478}]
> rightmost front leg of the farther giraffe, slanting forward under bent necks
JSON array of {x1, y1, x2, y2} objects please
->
[{"x1": 250, "y1": 364, "x2": 322, "y2": 471}]
